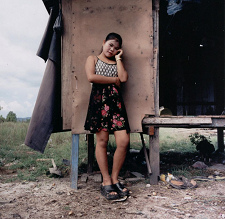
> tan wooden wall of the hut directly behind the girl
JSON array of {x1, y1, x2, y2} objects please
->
[{"x1": 62, "y1": 0, "x2": 154, "y2": 134}]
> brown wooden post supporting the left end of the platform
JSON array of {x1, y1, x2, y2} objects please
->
[{"x1": 149, "y1": 128, "x2": 160, "y2": 185}]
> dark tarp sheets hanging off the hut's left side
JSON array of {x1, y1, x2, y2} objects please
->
[{"x1": 25, "y1": 1, "x2": 62, "y2": 153}]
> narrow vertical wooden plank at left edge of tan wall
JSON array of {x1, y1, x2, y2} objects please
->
[{"x1": 61, "y1": 0, "x2": 73, "y2": 130}]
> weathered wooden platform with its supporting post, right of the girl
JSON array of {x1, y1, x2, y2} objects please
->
[{"x1": 142, "y1": 115, "x2": 225, "y2": 184}]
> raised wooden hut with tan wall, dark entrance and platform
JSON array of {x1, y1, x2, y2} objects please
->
[{"x1": 25, "y1": 0, "x2": 225, "y2": 188}]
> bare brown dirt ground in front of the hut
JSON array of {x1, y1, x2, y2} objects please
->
[{"x1": 0, "y1": 169, "x2": 225, "y2": 219}]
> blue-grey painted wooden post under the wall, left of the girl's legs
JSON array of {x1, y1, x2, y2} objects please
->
[{"x1": 71, "y1": 134, "x2": 79, "y2": 190}]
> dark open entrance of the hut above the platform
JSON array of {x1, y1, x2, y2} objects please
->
[{"x1": 159, "y1": 0, "x2": 225, "y2": 115}]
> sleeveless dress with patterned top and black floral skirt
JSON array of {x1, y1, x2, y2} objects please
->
[{"x1": 84, "y1": 58, "x2": 130, "y2": 133}]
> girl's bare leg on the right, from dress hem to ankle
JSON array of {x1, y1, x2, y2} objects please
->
[{"x1": 111, "y1": 130, "x2": 130, "y2": 184}]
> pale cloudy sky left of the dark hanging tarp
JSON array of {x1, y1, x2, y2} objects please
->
[{"x1": 0, "y1": 0, "x2": 49, "y2": 118}]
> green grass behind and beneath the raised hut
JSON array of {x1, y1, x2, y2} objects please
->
[{"x1": 0, "y1": 122, "x2": 216, "y2": 181}]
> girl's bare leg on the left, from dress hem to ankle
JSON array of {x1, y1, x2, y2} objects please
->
[{"x1": 95, "y1": 131, "x2": 112, "y2": 186}]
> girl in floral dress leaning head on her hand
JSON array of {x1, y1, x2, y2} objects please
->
[{"x1": 84, "y1": 33, "x2": 130, "y2": 200}]
